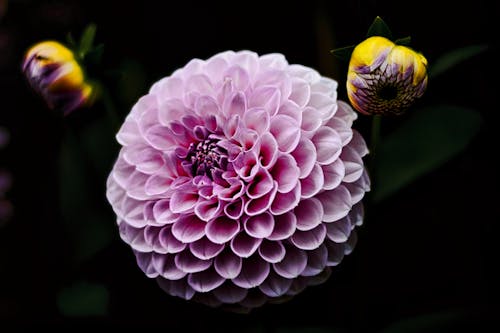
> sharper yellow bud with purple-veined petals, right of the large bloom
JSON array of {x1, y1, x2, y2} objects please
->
[{"x1": 347, "y1": 36, "x2": 427, "y2": 114}]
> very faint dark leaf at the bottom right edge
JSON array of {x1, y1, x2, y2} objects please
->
[{"x1": 381, "y1": 310, "x2": 466, "y2": 333}]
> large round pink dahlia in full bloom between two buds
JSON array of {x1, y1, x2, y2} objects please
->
[{"x1": 107, "y1": 51, "x2": 369, "y2": 309}]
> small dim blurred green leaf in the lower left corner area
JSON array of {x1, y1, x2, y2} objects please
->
[{"x1": 57, "y1": 281, "x2": 109, "y2": 317}]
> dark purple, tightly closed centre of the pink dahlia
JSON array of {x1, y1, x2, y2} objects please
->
[{"x1": 186, "y1": 139, "x2": 227, "y2": 180}]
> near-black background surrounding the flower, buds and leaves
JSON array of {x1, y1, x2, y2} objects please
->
[{"x1": 0, "y1": 0, "x2": 500, "y2": 332}]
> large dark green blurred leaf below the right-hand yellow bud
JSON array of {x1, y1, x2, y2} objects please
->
[{"x1": 372, "y1": 105, "x2": 481, "y2": 202}]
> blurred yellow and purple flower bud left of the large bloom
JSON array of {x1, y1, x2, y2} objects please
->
[{"x1": 22, "y1": 41, "x2": 92, "y2": 115}]
